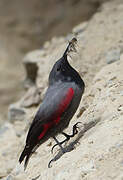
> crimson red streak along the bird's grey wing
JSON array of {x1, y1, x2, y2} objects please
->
[{"x1": 38, "y1": 88, "x2": 74, "y2": 140}]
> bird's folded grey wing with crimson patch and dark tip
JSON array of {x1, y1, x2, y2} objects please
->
[{"x1": 26, "y1": 87, "x2": 74, "y2": 144}]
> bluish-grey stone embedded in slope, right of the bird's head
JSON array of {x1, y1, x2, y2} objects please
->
[{"x1": 106, "y1": 49, "x2": 120, "y2": 64}]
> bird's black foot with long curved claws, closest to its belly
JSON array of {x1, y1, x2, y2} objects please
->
[{"x1": 51, "y1": 122, "x2": 81, "y2": 153}]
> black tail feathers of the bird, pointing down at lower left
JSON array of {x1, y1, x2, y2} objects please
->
[{"x1": 19, "y1": 146, "x2": 32, "y2": 170}]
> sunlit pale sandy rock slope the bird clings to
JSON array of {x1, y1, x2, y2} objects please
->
[{"x1": 0, "y1": 0, "x2": 123, "y2": 180}]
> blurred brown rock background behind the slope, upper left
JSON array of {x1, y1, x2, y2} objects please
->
[{"x1": 0, "y1": 0, "x2": 102, "y2": 125}]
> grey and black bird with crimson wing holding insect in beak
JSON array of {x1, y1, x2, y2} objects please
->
[{"x1": 19, "y1": 37, "x2": 85, "y2": 169}]
